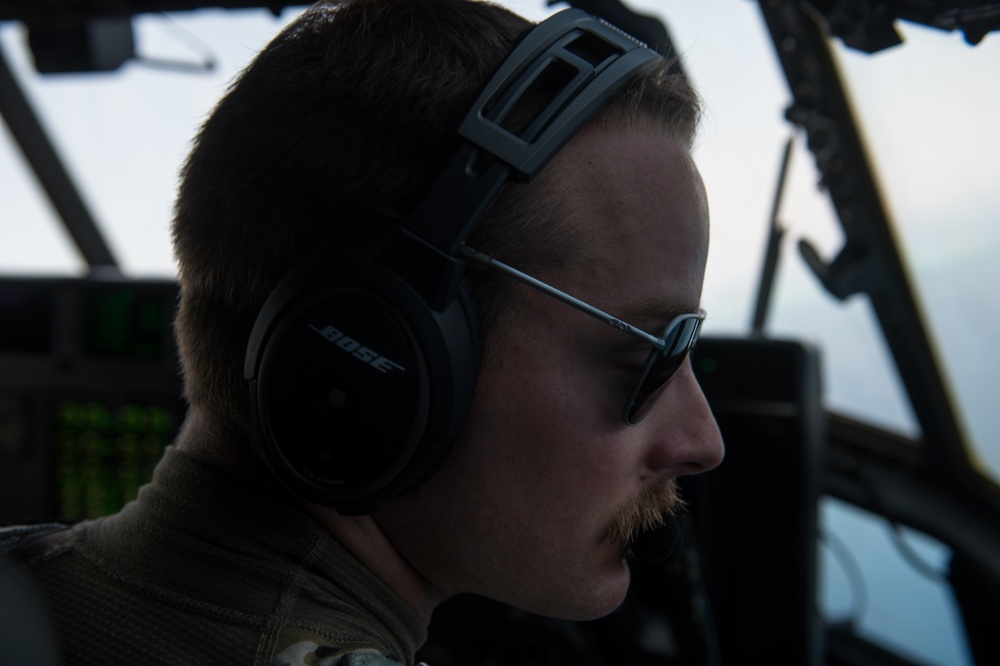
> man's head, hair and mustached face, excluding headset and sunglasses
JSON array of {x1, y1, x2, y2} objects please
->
[{"x1": 175, "y1": 0, "x2": 721, "y2": 617}]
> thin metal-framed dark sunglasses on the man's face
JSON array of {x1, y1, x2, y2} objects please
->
[{"x1": 459, "y1": 245, "x2": 705, "y2": 425}]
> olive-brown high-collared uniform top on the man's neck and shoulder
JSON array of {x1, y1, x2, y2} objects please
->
[{"x1": 0, "y1": 449, "x2": 426, "y2": 666}]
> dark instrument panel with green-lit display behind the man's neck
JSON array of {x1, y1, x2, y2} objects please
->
[{"x1": 0, "y1": 278, "x2": 184, "y2": 522}]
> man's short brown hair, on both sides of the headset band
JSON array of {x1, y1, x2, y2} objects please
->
[{"x1": 173, "y1": 0, "x2": 698, "y2": 441}]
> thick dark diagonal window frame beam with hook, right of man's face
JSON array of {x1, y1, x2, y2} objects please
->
[{"x1": 760, "y1": 0, "x2": 977, "y2": 492}]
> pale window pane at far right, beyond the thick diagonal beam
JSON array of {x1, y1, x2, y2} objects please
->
[{"x1": 836, "y1": 22, "x2": 1000, "y2": 484}]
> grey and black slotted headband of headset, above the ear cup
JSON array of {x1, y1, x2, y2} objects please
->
[{"x1": 374, "y1": 9, "x2": 662, "y2": 311}]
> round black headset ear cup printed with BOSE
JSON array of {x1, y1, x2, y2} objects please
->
[{"x1": 245, "y1": 244, "x2": 478, "y2": 513}]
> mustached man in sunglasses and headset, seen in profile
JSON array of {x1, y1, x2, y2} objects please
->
[{"x1": 0, "y1": 0, "x2": 722, "y2": 665}]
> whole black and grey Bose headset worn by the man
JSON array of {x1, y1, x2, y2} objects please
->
[{"x1": 244, "y1": 9, "x2": 661, "y2": 515}]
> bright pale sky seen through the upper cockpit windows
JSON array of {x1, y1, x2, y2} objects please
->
[{"x1": 0, "y1": 0, "x2": 1000, "y2": 663}]
